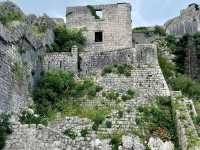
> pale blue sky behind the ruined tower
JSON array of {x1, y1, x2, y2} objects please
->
[{"x1": 0, "y1": 0, "x2": 200, "y2": 27}]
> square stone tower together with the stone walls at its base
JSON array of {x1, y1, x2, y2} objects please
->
[{"x1": 44, "y1": 3, "x2": 169, "y2": 96}]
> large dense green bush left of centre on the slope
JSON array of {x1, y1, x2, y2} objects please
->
[{"x1": 33, "y1": 70, "x2": 102, "y2": 117}]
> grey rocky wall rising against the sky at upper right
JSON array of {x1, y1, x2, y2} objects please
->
[{"x1": 164, "y1": 4, "x2": 200, "y2": 35}]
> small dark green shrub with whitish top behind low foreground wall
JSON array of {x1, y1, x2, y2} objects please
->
[{"x1": 19, "y1": 109, "x2": 48, "y2": 125}]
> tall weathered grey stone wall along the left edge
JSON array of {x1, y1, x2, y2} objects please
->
[{"x1": 0, "y1": 23, "x2": 52, "y2": 113}]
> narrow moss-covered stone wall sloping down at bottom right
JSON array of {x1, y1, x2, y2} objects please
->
[{"x1": 172, "y1": 92, "x2": 200, "y2": 150}]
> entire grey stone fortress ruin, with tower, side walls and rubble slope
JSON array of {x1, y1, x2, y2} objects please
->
[{"x1": 0, "y1": 1, "x2": 200, "y2": 150}]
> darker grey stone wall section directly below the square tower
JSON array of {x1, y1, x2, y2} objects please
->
[{"x1": 80, "y1": 48, "x2": 135, "y2": 75}]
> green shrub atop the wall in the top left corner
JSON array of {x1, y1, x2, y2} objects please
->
[{"x1": 0, "y1": 6, "x2": 24, "y2": 25}]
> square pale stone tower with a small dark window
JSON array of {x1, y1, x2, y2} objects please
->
[{"x1": 66, "y1": 3, "x2": 132, "y2": 51}]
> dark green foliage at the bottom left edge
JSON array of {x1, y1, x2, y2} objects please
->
[{"x1": 0, "y1": 113, "x2": 12, "y2": 150}]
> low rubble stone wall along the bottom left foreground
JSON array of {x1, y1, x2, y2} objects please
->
[{"x1": 4, "y1": 124, "x2": 111, "y2": 150}]
